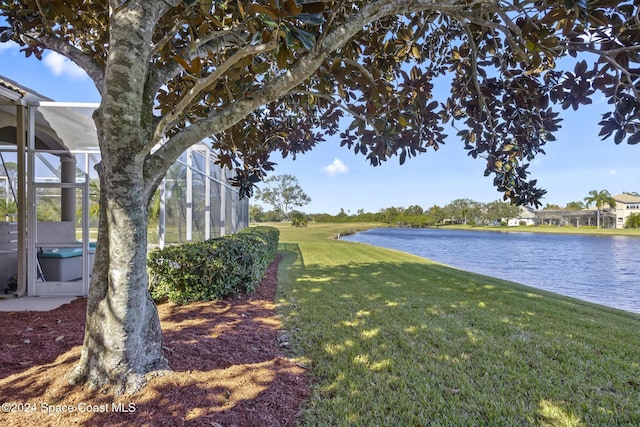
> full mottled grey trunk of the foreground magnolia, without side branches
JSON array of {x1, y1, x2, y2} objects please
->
[{"x1": 70, "y1": 2, "x2": 169, "y2": 394}]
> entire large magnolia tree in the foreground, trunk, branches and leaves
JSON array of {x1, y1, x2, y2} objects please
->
[{"x1": 0, "y1": 0, "x2": 640, "y2": 392}]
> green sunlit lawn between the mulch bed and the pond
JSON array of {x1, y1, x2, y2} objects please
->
[{"x1": 278, "y1": 224, "x2": 640, "y2": 426}]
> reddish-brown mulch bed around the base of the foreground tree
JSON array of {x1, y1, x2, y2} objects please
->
[{"x1": 0, "y1": 255, "x2": 309, "y2": 427}]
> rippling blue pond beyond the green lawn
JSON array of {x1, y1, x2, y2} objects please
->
[{"x1": 343, "y1": 228, "x2": 640, "y2": 313}]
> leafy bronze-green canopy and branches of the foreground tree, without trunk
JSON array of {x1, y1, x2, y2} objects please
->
[{"x1": 0, "y1": 0, "x2": 640, "y2": 207}]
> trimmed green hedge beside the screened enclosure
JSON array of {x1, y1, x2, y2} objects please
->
[{"x1": 147, "y1": 227, "x2": 280, "y2": 304}]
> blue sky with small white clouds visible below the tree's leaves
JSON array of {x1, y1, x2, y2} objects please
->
[{"x1": 0, "y1": 39, "x2": 640, "y2": 214}]
